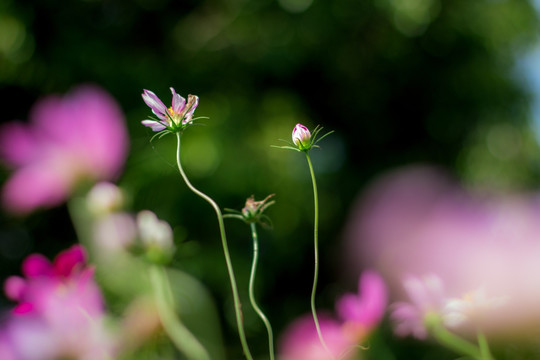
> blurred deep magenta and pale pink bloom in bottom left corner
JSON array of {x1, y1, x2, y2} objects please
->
[{"x1": 2, "y1": 245, "x2": 113, "y2": 360}]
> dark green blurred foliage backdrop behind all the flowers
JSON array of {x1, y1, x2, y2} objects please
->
[{"x1": 0, "y1": 0, "x2": 540, "y2": 359}]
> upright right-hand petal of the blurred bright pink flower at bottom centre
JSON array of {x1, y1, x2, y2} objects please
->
[{"x1": 336, "y1": 270, "x2": 388, "y2": 343}]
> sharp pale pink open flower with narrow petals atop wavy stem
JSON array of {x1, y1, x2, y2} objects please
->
[{"x1": 141, "y1": 87, "x2": 199, "y2": 133}]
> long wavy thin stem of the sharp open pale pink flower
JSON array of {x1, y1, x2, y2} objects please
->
[{"x1": 176, "y1": 132, "x2": 253, "y2": 360}]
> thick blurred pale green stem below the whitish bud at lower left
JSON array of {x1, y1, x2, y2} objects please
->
[{"x1": 149, "y1": 265, "x2": 210, "y2": 360}]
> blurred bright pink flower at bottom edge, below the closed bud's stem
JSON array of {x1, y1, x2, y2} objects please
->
[{"x1": 280, "y1": 270, "x2": 387, "y2": 360}]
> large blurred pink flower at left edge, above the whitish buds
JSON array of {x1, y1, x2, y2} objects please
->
[{"x1": 0, "y1": 85, "x2": 128, "y2": 213}]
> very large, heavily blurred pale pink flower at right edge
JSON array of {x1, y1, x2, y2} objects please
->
[{"x1": 345, "y1": 166, "x2": 540, "y2": 337}]
